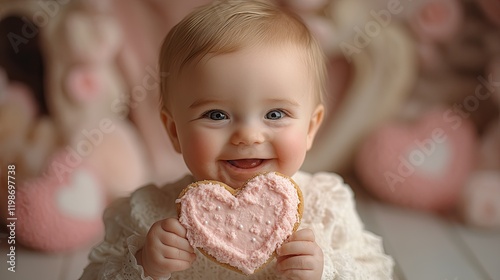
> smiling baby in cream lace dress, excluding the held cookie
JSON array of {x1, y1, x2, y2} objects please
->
[{"x1": 81, "y1": 0, "x2": 393, "y2": 280}]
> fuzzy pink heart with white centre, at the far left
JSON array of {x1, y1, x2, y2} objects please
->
[{"x1": 16, "y1": 150, "x2": 105, "y2": 252}]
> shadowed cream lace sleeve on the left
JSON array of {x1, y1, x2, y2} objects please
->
[{"x1": 80, "y1": 186, "x2": 177, "y2": 280}]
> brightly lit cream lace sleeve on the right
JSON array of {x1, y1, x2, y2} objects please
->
[{"x1": 297, "y1": 173, "x2": 393, "y2": 279}]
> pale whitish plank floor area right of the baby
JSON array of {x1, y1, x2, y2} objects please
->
[{"x1": 357, "y1": 177, "x2": 500, "y2": 280}]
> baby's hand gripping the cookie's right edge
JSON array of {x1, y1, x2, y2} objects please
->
[{"x1": 276, "y1": 229, "x2": 323, "y2": 280}]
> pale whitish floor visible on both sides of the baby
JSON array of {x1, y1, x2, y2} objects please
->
[{"x1": 0, "y1": 179, "x2": 500, "y2": 280}]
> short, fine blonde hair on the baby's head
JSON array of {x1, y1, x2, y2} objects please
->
[{"x1": 159, "y1": 0, "x2": 326, "y2": 110}]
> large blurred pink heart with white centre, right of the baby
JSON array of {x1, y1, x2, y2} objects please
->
[{"x1": 355, "y1": 110, "x2": 476, "y2": 210}]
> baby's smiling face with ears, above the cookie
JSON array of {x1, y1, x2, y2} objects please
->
[{"x1": 164, "y1": 46, "x2": 323, "y2": 188}]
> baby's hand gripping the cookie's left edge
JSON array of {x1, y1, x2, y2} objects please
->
[{"x1": 135, "y1": 218, "x2": 196, "y2": 279}]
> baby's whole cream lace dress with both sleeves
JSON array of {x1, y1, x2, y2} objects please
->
[{"x1": 80, "y1": 171, "x2": 393, "y2": 280}]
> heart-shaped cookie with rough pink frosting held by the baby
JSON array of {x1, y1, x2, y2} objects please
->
[{"x1": 176, "y1": 172, "x2": 303, "y2": 274}]
